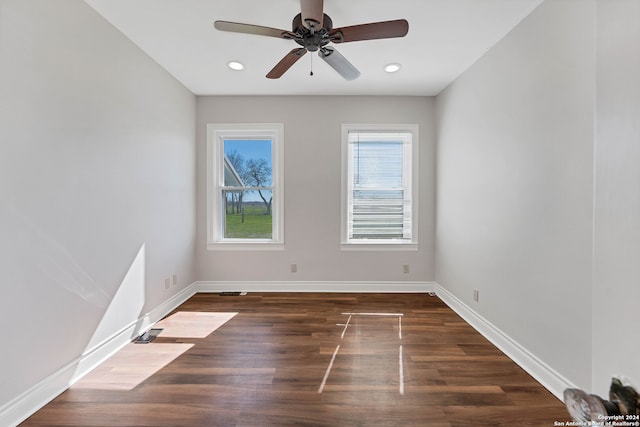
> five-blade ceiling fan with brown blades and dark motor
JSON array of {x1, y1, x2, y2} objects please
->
[{"x1": 214, "y1": 0, "x2": 409, "y2": 80}]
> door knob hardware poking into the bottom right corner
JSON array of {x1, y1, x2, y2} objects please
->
[{"x1": 564, "y1": 378, "x2": 640, "y2": 425}]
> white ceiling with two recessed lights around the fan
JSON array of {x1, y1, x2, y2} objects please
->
[{"x1": 85, "y1": 0, "x2": 543, "y2": 95}]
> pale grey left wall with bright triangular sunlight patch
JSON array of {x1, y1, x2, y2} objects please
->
[{"x1": 0, "y1": 0, "x2": 195, "y2": 412}]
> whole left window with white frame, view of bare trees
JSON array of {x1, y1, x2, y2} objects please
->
[{"x1": 207, "y1": 124, "x2": 284, "y2": 249}]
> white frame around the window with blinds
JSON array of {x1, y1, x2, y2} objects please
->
[{"x1": 341, "y1": 124, "x2": 420, "y2": 251}]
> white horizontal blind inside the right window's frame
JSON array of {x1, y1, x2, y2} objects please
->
[{"x1": 347, "y1": 131, "x2": 412, "y2": 241}]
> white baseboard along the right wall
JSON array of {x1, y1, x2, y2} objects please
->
[{"x1": 435, "y1": 283, "x2": 576, "y2": 400}]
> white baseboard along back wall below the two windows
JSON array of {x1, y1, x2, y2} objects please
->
[{"x1": 195, "y1": 281, "x2": 435, "y2": 293}]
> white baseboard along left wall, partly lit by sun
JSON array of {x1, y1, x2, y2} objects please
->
[{"x1": 0, "y1": 284, "x2": 195, "y2": 426}]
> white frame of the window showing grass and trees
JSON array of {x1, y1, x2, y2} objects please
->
[{"x1": 207, "y1": 123, "x2": 284, "y2": 250}]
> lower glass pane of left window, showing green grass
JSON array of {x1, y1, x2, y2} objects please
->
[{"x1": 222, "y1": 190, "x2": 273, "y2": 239}]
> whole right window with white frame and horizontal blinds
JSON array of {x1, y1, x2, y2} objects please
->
[{"x1": 342, "y1": 125, "x2": 418, "y2": 250}]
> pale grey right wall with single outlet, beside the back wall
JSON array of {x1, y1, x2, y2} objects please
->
[{"x1": 436, "y1": 0, "x2": 595, "y2": 389}]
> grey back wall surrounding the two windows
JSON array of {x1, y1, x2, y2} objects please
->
[{"x1": 197, "y1": 96, "x2": 435, "y2": 282}]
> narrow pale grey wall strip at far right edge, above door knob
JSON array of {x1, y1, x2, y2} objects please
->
[{"x1": 592, "y1": 0, "x2": 640, "y2": 395}]
